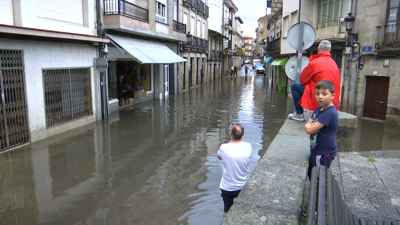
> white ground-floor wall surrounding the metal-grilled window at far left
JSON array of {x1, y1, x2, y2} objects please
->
[{"x1": 0, "y1": 39, "x2": 98, "y2": 142}]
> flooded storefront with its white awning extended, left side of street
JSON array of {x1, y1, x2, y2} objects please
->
[{"x1": 107, "y1": 34, "x2": 186, "y2": 112}]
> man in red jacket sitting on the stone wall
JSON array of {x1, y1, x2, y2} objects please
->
[{"x1": 288, "y1": 40, "x2": 340, "y2": 121}]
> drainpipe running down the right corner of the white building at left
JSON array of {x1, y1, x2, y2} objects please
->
[{"x1": 96, "y1": 0, "x2": 108, "y2": 120}]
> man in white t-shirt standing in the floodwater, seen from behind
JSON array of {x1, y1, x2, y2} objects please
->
[{"x1": 217, "y1": 124, "x2": 252, "y2": 218}]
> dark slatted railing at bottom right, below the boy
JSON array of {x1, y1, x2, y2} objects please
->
[{"x1": 306, "y1": 166, "x2": 397, "y2": 225}]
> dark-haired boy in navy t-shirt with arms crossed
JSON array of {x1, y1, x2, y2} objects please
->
[{"x1": 304, "y1": 80, "x2": 339, "y2": 178}]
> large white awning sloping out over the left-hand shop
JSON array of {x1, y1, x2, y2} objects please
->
[{"x1": 107, "y1": 34, "x2": 187, "y2": 64}]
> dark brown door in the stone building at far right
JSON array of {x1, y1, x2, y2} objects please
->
[{"x1": 363, "y1": 76, "x2": 390, "y2": 120}]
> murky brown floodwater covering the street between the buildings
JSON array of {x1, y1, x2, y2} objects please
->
[{"x1": 0, "y1": 76, "x2": 293, "y2": 225}]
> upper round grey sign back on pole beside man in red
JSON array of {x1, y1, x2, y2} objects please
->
[{"x1": 287, "y1": 22, "x2": 315, "y2": 50}]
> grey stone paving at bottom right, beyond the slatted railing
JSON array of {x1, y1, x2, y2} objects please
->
[{"x1": 331, "y1": 150, "x2": 400, "y2": 222}]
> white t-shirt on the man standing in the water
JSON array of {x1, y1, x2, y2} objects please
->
[{"x1": 217, "y1": 141, "x2": 252, "y2": 191}]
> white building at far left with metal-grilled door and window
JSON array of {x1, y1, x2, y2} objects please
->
[{"x1": 0, "y1": 0, "x2": 109, "y2": 151}]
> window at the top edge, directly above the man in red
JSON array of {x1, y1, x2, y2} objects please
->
[{"x1": 317, "y1": 0, "x2": 341, "y2": 28}]
